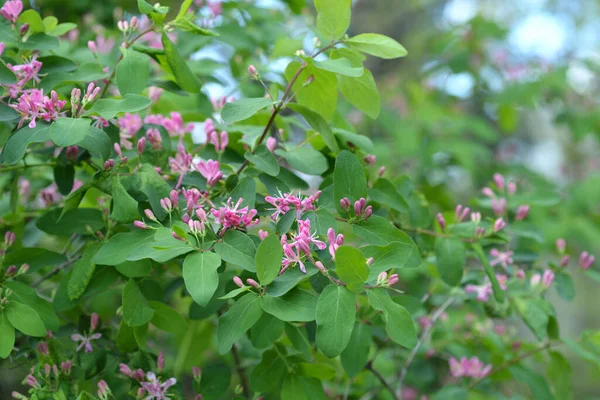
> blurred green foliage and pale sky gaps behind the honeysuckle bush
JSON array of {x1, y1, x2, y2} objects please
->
[{"x1": 2, "y1": 0, "x2": 600, "y2": 399}]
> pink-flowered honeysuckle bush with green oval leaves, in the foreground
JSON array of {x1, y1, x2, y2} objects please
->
[{"x1": 0, "y1": 0, "x2": 600, "y2": 399}]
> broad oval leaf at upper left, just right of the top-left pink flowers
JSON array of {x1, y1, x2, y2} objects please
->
[{"x1": 116, "y1": 49, "x2": 150, "y2": 96}]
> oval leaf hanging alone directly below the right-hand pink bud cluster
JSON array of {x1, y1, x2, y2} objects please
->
[{"x1": 435, "y1": 237, "x2": 467, "y2": 286}]
